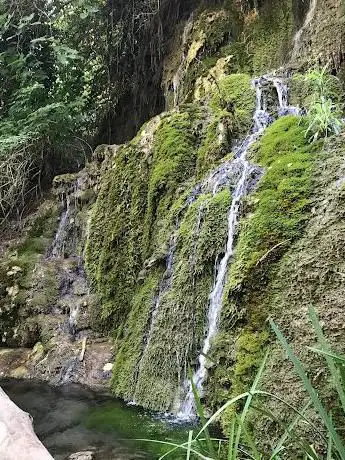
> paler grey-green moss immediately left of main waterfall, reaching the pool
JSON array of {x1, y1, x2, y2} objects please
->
[{"x1": 109, "y1": 190, "x2": 231, "y2": 410}]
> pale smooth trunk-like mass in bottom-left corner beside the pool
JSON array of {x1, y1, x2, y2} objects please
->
[{"x1": 0, "y1": 388, "x2": 54, "y2": 460}]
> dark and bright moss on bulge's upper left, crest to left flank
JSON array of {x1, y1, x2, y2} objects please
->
[{"x1": 86, "y1": 112, "x2": 196, "y2": 329}]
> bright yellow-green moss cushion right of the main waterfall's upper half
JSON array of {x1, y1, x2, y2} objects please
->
[{"x1": 224, "y1": 116, "x2": 312, "y2": 289}]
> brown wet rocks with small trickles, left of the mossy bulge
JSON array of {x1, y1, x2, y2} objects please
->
[{"x1": 0, "y1": 156, "x2": 113, "y2": 389}]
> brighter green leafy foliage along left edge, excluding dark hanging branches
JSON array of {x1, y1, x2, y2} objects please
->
[{"x1": 0, "y1": 0, "x2": 96, "y2": 217}]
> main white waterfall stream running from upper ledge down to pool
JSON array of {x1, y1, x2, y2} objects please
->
[{"x1": 178, "y1": 76, "x2": 298, "y2": 419}]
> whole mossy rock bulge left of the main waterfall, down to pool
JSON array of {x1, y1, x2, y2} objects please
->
[{"x1": 86, "y1": 74, "x2": 255, "y2": 410}]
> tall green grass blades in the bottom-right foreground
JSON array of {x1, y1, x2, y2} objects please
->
[{"x1": 140, "y1": 307, "x2": 345, "y2": 460}]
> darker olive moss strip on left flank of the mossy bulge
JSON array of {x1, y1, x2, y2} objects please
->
[{"x1": 85, "y1": 145, "x2": 149, "y2": 328}]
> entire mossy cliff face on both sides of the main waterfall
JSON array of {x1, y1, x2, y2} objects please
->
[{"x1": 81, "y1": 0, "x2": 341, "y2": 416}]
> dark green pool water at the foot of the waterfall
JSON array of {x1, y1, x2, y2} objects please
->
[{"x1": 0, "y1": 380, "x2": 190, "y2": 460}]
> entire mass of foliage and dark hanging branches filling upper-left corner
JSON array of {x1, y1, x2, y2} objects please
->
[{"x1": 0, "y1": 0, "x2": 183, "y2": 218}]
